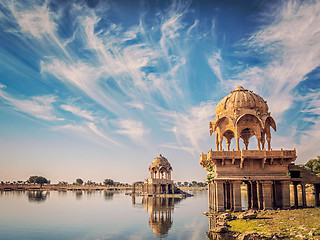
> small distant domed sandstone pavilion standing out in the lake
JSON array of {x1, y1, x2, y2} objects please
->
[{"x1": 132, "y1": 154, "x2": 175, "y2": 195}]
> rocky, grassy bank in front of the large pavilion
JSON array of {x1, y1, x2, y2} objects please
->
[{"x1": 208, "y1": 207, "x2": 320, "y2": 240}]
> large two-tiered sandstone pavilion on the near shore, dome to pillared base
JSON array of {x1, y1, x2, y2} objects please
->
[{"x1": 200, "y1": 86, "x2": 296, "y2": 211}]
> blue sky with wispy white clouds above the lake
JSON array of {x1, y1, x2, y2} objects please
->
[{"x1": 0, "y1": 0, "x2": 320, "y2": 183}]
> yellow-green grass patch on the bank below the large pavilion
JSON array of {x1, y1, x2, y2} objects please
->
[{"x1": 228, "y1": 207, "x2": 320, "y2": 239}]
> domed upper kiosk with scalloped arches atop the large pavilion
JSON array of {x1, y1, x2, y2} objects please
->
[{"x1": 209, "y1": 86, "x2": 276, "y2": 151}]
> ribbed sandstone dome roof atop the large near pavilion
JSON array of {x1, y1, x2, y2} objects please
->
[{"x1": 216, "y1": 86, "x2": 268, "y2": 115}]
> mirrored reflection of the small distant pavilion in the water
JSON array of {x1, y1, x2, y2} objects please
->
[{"x1": 132, "y1": 196, "x2": 182, "y2": 238}]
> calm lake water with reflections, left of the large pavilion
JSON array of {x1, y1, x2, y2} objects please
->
[{"x1": 0, "y1": 191, "x2": 209, "y2": 240}]
